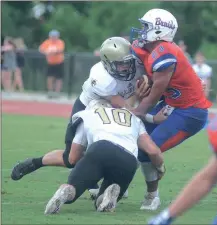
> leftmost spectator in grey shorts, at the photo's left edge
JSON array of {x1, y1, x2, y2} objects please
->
[{"x1": 1, "y1": 37, "x2": 17, "y2": 92}]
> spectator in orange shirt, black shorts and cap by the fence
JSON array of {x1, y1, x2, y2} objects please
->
[{"x1": 39, "y1": 30, "x2": 65, "y2": 97}]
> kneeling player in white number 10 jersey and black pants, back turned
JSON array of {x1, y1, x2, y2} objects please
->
[{"x1": 45, "y1": 100, "x2": 165, "y2": 214}]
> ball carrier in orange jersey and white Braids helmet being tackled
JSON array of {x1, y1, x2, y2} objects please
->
[{"x1": 132, "y1": 9, "x2": 211, "y2": 210}]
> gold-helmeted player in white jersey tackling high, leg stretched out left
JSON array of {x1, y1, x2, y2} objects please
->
[{"x1": 11, "y1": 37, "x2": 165, "y2": 199}]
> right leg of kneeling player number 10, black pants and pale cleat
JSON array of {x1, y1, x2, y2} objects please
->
[{"x1": 95, "y1": 142, "x2": 137, "y2": 211}]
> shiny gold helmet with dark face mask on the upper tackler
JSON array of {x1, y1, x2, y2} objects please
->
[{"x1": 100, "y1": 37, "x2": 136, "y2": 81}]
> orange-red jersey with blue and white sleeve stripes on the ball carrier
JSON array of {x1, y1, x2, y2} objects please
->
[{"x1": 132, "y1": 41, "x2": 212, "y2": 109}]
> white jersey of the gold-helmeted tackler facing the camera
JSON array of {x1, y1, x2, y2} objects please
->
[{"x1": 80, "y1": 62, "x2": 145, "y2": 106}]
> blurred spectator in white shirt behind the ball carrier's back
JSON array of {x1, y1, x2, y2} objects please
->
[{"x1": 193, "y1": 52, "x2": 212, "y2": 97}]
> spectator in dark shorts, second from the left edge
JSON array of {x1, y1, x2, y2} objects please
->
[{"x1": 13, "y1": 38, "x2": 26, "y2": 91}]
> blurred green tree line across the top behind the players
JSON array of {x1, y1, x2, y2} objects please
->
[{"x1": 2, "y1": 1, "x2": 217, "y2": 58}]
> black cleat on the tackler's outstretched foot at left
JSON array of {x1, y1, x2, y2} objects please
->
[{"x1": 11, "y1": 159, "x2": 36, "y2": 180}]
